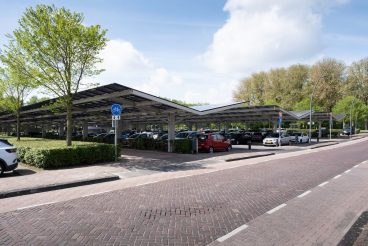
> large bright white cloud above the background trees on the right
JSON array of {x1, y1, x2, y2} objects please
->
[{"x1": 200, "y1": 0, "x2": 347, "y2": 74}]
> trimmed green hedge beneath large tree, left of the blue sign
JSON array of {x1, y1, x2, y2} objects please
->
[{"x1": 18, "y1": 144, "x2": 120, "y2": 168}]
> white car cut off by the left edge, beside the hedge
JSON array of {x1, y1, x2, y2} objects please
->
[{"x1": 0, "y1": 139, "x2": 18, "y2": 174}]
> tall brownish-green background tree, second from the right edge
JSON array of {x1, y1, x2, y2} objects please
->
[{"x1": 309, "y1": 58, "x2": 346, "y2": 112}]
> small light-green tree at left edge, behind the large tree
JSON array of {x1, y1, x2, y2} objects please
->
[{"x1": 0, "y1": 67, "x2": 34, "y2": 141}]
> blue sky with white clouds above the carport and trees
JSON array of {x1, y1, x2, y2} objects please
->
[{"x1": 0, "y1": 0, "x2": 368, "y2": 104}]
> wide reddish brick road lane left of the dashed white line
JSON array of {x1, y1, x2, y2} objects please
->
[{"x1": 0, "y1": 141, "x2": 368, "y2": 245}]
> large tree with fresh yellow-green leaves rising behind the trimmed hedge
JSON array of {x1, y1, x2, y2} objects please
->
[{"x1": 5, "y1": 5, "x2": 107, "y2": 146}]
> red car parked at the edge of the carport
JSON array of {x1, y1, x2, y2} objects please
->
[{"x1": 198, "y1": 133, "x2": 231, "y2": 153}]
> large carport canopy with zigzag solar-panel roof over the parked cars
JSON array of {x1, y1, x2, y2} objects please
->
[{"x1": 0, "y1": 83, "x2": 344, "y2": 151}]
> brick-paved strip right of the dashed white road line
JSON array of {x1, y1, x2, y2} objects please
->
[{"x1": 210, "y1": 161, "x2": 368, "y2": 246}]
